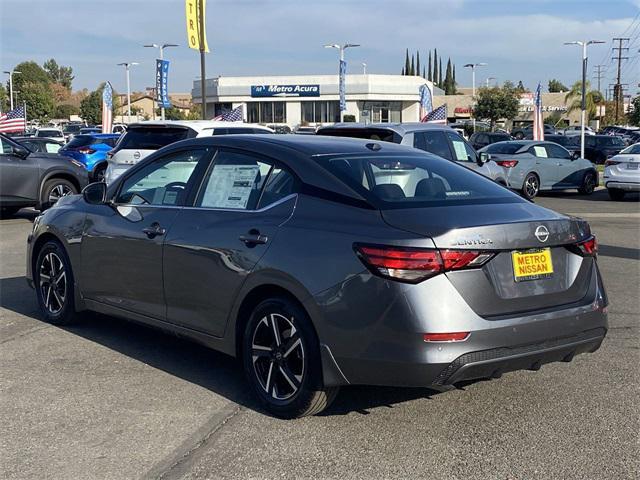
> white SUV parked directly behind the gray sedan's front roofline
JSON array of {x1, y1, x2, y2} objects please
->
[{"x1": 104, "y1": 120, "x2": 273, "y2": 184}]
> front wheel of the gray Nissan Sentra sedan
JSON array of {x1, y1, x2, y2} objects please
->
[{"x1": 33, "y1": 240, "x2": 79, "y2": 325}]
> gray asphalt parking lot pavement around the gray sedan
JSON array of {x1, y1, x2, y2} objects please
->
[{"x1": 0, "y1": 190, "x2": 640, "y2": 479}]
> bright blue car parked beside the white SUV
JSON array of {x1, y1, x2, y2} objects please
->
[{"x1": 58, "y1": 133, "x2": 120, "y2": 182}]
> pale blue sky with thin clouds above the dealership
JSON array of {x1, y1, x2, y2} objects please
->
[{"x1": 0, "y1": 0, "x2": 640, "y2": 93}]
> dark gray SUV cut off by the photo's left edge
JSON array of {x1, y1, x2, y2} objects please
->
[{"x1": 0, "y1": 130, "x2": 88, "y2": 216}]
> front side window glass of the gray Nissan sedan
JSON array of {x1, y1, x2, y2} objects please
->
[{"x1": 116, "y1": 149, "x2": 208, "y2": 206}]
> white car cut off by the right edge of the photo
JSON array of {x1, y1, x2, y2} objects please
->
[{"x1": 604, "y1": 143, "x2": 640, "y2": 200}]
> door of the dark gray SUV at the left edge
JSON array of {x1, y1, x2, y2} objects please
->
[{"x1": 0, "y1": 137, "x2": 40, "y2": 206}]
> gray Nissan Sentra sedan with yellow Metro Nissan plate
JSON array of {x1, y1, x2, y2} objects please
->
[{"x1": 27, "y1": 135, "x2": 607, "y2": 418}]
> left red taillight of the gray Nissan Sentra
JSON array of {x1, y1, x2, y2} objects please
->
[{"x1": 355, "y1": 245, "x2": 493, "y2": 283}]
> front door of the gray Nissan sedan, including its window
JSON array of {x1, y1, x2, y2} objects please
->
[{"x1": 80, "y1": 147, "x2": 211, "y2": 319}]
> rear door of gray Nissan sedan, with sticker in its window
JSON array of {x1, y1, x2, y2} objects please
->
[{"x1": 163, "y1": 149, "x2": 296, "y2": 336}]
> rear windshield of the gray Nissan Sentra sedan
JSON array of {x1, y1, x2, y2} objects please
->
[{"x1": 317, "y1": 153, "x2": 522, "y2": 210}]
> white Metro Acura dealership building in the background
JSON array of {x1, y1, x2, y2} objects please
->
[{"x1": 192, "y1": 74, "x2": 444, "y2": 127}]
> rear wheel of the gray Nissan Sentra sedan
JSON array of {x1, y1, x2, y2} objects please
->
[{"x1": 242, "y1": 297, "x2": 339, "y2": 419}]
